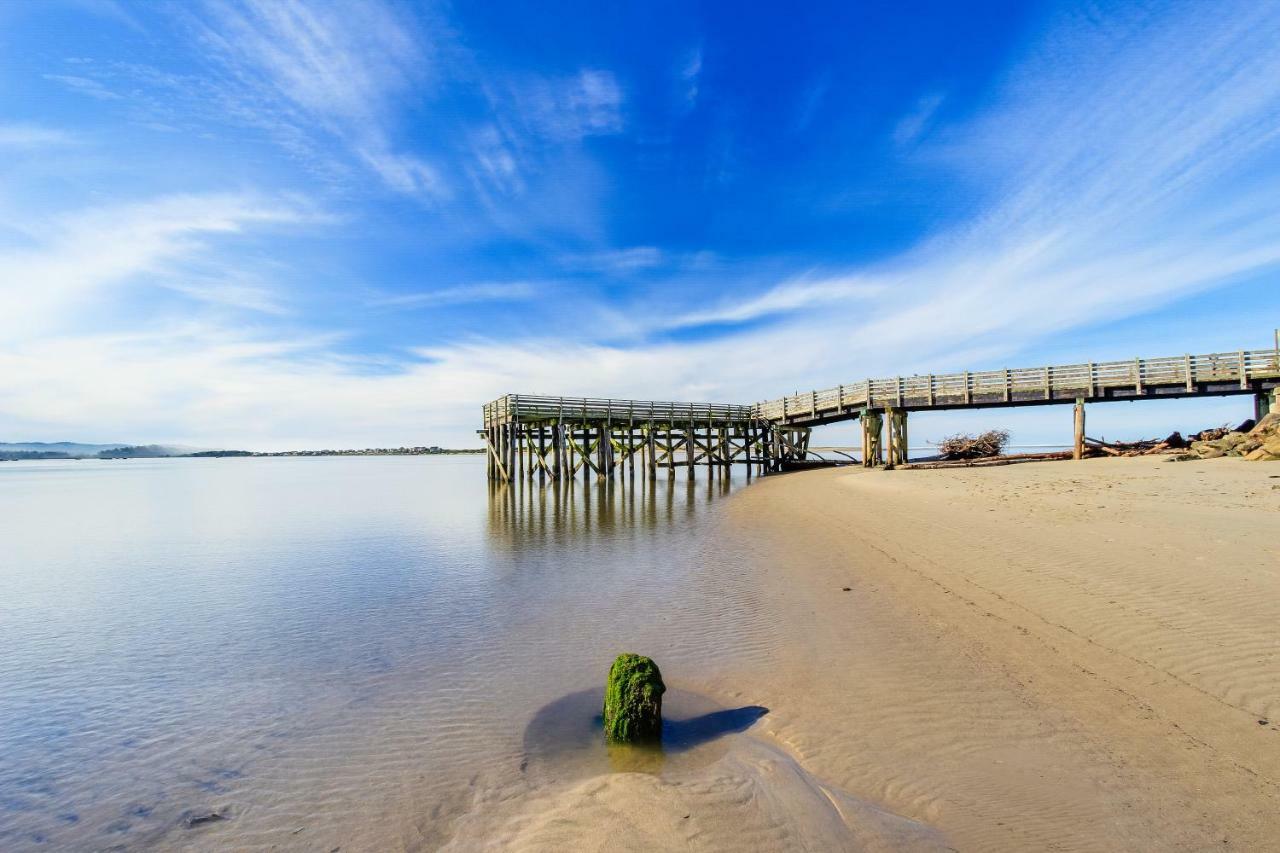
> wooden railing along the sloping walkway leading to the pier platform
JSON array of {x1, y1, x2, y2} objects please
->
[{"x1": 753, "y1": 350, "x2": 1280, "y2": 423}]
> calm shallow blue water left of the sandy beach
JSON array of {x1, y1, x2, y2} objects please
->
[{"x1": 0, "y1": 457, "x2": 767, "y2": 850}]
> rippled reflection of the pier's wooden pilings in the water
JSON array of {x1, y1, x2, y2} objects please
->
[{"x1": 489, "y1": 461, "x2": 746, "y2": 542}]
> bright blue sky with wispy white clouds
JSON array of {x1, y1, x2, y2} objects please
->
[{"x1": 0, "y1": 0, "x2": 1280, "y2": 450}]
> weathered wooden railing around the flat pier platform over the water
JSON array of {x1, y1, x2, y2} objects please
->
[{"x1": 484, "y1": 394, "x2": 754, "y2": 428}]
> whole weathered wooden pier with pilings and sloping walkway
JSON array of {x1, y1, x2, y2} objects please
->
[{"x1": 480, "y1": 347, "x2": 1280, "y2": 480}]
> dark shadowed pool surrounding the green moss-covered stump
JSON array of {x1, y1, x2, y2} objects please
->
[{"x1": 521, "y1": 688, "x2": 769, "y2": 777}]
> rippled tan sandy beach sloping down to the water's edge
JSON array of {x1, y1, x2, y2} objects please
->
[{"x1": 454, "y1": 457, "x2": 1280, "y2": 850}]
